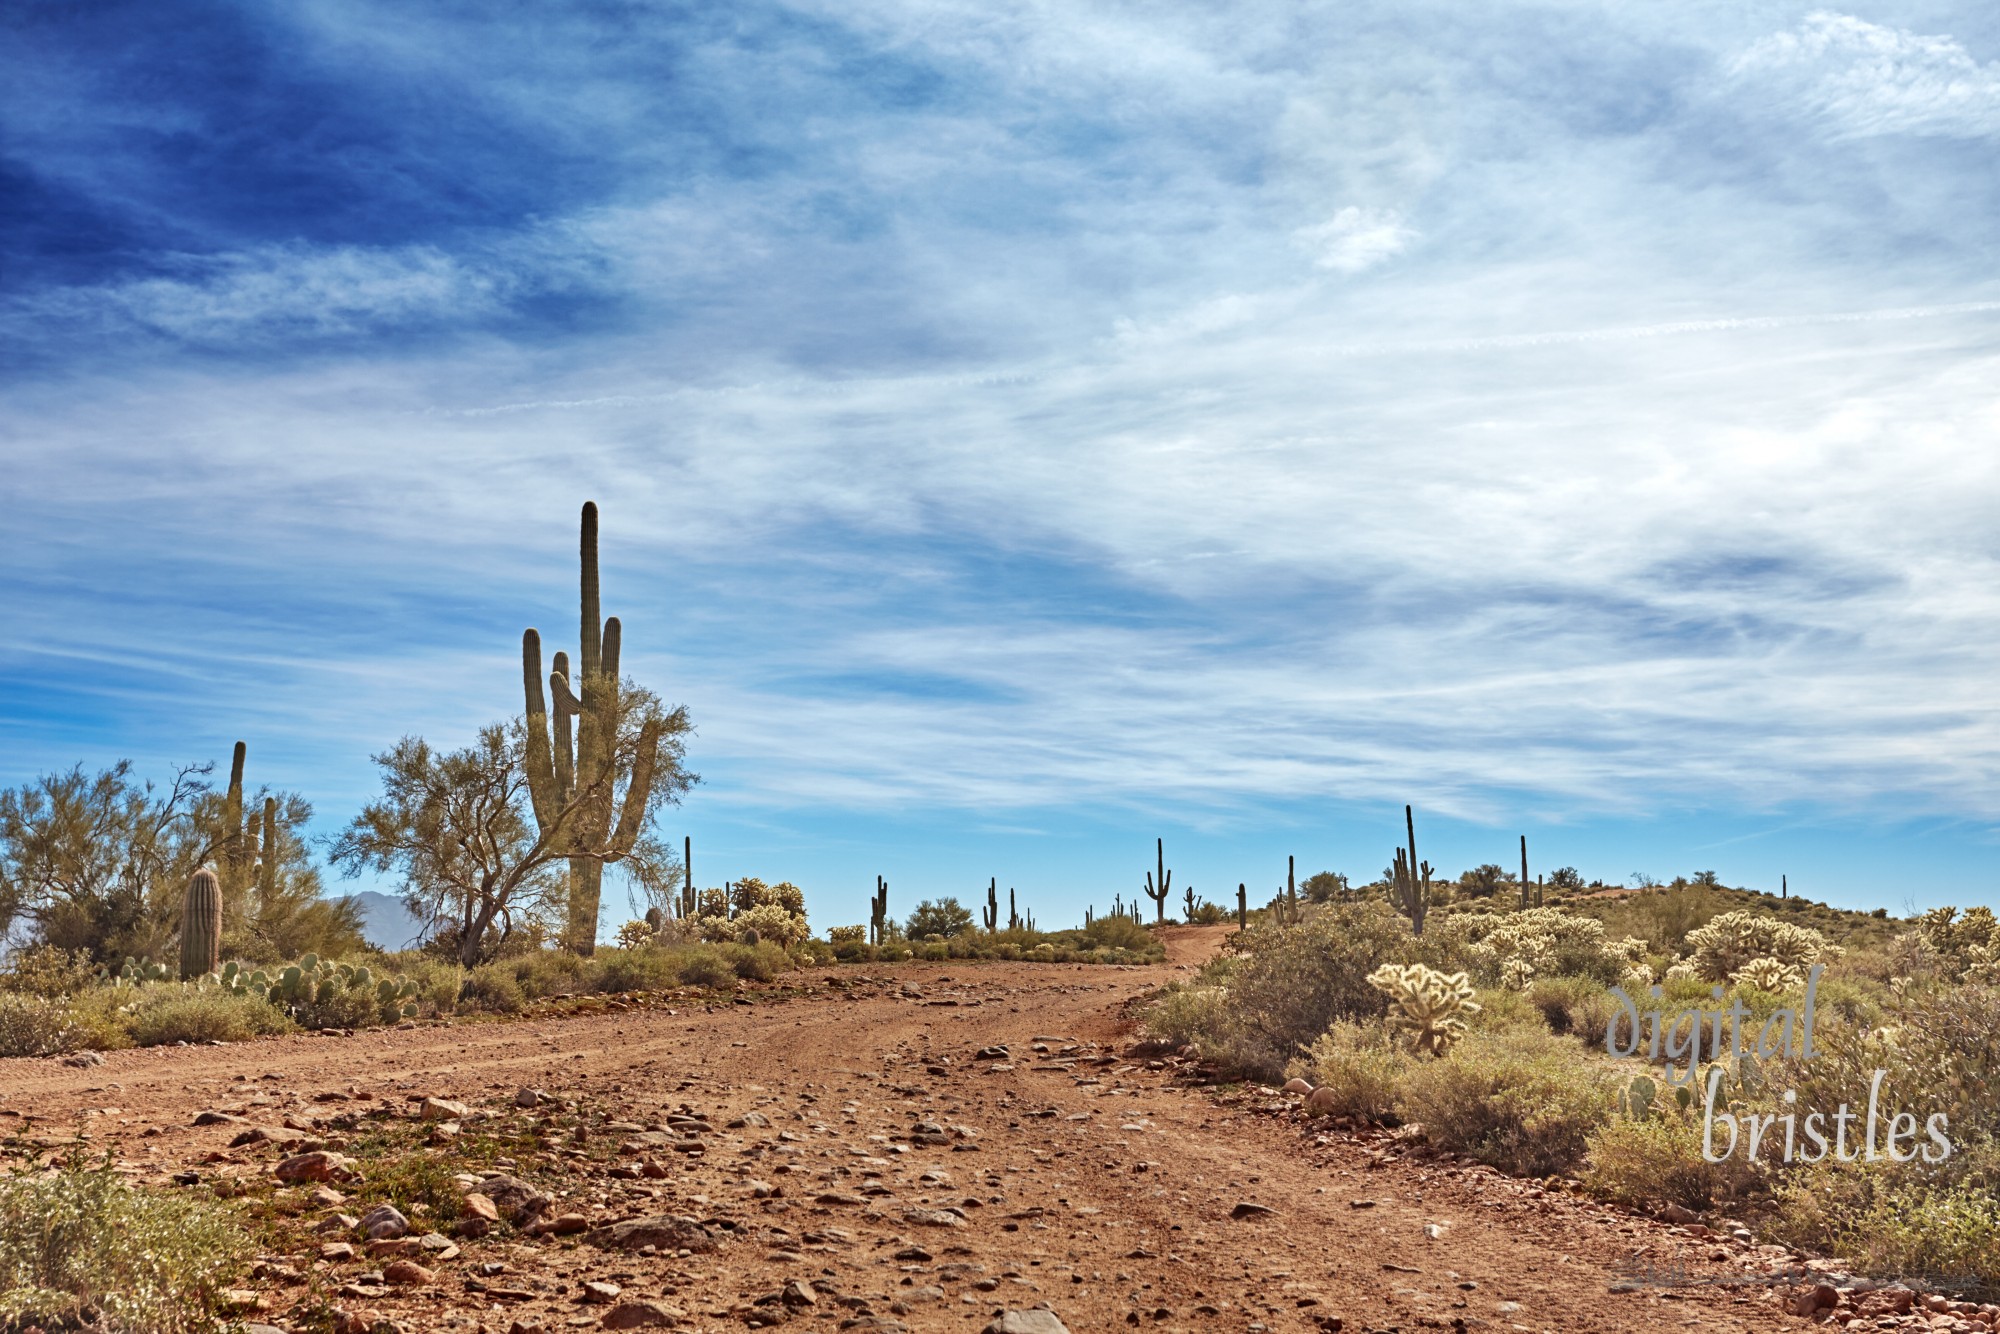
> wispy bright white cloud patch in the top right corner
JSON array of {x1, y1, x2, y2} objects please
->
[{"x1": 1728, "y1": 10, "x2": 2000, "y2": 138}]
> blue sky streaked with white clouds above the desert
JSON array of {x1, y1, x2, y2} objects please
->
[{"x1": 0, "y1": 0, "x2": 2000, "y2": 940}]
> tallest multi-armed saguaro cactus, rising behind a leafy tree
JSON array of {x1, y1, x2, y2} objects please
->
[{"x1": 520, "y1": 502, "x2": 662, "y2": 954}]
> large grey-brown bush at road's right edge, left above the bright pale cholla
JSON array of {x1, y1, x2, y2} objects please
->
[{"x1": 1204, "y1": 902, "x2": 1410, "y2": 1082}]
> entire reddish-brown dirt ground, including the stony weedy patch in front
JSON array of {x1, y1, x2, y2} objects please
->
[{"x1": 0, "y1": 928, "x2": 1986, "y2": 1334}]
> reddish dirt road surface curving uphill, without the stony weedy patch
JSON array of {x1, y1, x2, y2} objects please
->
[{"x1": 0, "y1": 930, "x2": 1804, "y2": 1334}]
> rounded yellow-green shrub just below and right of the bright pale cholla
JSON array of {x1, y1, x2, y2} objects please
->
[{"x1": 1396, "y1": 1032, "x2": 1614, "y2": 1176}]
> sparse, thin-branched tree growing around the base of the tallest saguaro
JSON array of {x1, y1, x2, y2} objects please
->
[{"x1": 328, "y1": 704, "x2": 696, "y2": 968}]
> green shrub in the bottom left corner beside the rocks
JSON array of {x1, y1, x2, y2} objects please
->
[{"x1": 0, "y1": 1158, "x2": 252, "y2": 1334}]
